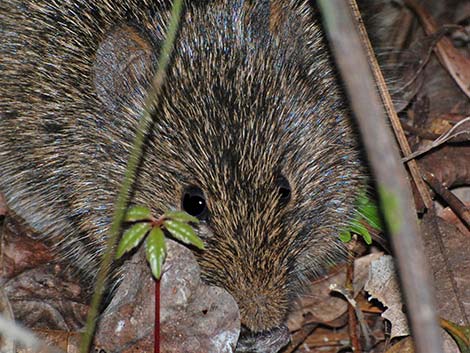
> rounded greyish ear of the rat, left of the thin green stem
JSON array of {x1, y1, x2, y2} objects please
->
[{"x1": 93, "y1": 25, "x2": 158, "y2": 111}]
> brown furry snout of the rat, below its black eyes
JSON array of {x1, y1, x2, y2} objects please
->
[{"x1": 199, "y1": 213, "x2": 292, "y2": 334}]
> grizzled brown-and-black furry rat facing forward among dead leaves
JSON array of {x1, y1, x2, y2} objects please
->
[{"x1": 0, "y1": 0, "x2": 365, "y2": 350}]
